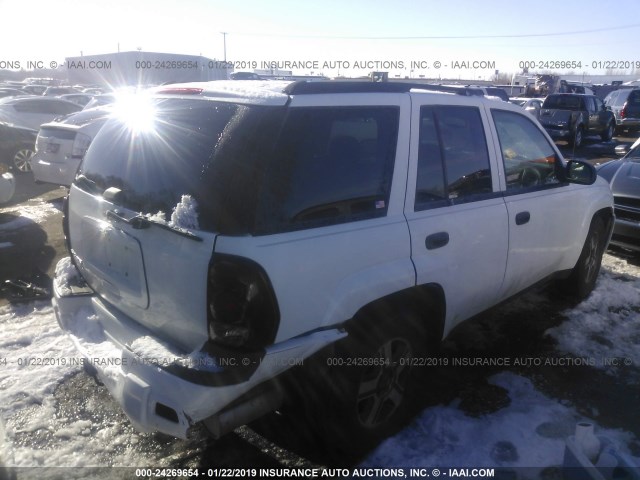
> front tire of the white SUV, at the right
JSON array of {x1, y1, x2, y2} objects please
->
[{"x1": 564, "y1": 217, "x2": 607, "y2": 300}]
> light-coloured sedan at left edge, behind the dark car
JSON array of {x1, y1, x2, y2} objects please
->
[{"x1": 0, "y1": 96, "x2": 82, "y2": 131}]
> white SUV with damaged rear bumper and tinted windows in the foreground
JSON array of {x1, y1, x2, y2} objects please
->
[{"x1": 54, "y1": 81, "x2": 613, "y2": 456}]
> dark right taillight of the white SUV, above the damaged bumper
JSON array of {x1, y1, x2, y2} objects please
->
[{"x1": 207, "y1": 254, "x2": 280, "y2": 350}]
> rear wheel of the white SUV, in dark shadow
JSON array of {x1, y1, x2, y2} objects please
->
[{"x1": 298, "y1": 308, "x2": 428, "y2": 463}]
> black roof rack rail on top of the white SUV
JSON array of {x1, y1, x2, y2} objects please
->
[{"x1": 283, "y1": 80, "x2": 484, "y2": 96}]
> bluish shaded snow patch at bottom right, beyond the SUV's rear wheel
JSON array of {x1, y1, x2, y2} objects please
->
[{"x1": 365, "y1": 372, "x2": 633, "y2": 470}]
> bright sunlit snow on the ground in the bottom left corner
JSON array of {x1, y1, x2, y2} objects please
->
[{"x1": 0, "y1": 302, "x2": 159, "y2": 467}]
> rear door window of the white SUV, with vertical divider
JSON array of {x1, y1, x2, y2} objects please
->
[{"x1": 414, "y1": 106, "x2": 492, "y2": 210}]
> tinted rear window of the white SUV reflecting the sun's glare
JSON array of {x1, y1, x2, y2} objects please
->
[{"x1": 77, "y1": 99, "x2": 284, "y2": 234}]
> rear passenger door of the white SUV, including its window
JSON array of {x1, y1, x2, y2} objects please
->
[{"x1": 405, "y1": 94, "x2": 509, "y2": 334}]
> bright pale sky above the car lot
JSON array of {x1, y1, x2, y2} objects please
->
[{"x1": 0, "y1": 0, "x2": 640, "y2": 78}]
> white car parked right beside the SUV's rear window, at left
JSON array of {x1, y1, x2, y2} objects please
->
[{"x1": 31, "y1": 107, "x2": 112, "y2": 187}]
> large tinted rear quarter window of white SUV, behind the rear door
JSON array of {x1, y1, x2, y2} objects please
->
[{"x1": 257, "y1": 106, "x2": 399, "y2": 233}]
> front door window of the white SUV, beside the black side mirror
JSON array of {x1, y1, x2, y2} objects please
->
[{"x1": 491, "y1": 109, "x2": 559, "y2": 191}]
